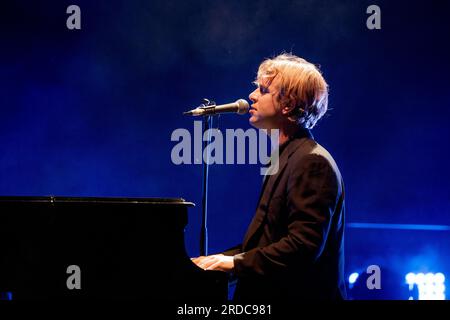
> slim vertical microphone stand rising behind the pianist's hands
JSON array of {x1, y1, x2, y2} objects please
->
[{"x1": 200, "y1": 99, "x2": 215, "y2": 256}]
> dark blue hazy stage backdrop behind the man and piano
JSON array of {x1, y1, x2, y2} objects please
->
[{"x1": 0, "y1": 0, "x2": 450, "y2": 300}]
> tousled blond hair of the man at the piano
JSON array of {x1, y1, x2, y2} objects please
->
[{"x1": 257, "y1": 53, "x2": 328, "y2": 129}]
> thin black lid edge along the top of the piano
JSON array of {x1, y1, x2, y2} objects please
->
[{"x1": 0, "y1": 196, "x2": 195, "y2": 207}]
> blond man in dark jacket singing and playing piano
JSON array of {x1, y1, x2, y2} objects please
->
[{"x1": 193, "y1": 54, "x2": 345, "y2": 301}]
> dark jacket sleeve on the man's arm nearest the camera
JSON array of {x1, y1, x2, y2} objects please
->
[{"x1": 234, "y1": 154, "x2": 339, "y2": 276}]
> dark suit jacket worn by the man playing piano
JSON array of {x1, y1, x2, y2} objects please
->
[{"x1": 224, "y1": 130, "x2": 345, "y2": 301}]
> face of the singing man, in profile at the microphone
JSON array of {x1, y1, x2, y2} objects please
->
[{"x1": 249, "y1": 77, "x2": 282, "y2": 129}]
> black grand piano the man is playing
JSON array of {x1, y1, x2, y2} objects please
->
[{"x1": 0, "y1": 197, "x2": 228, "y2": 302}]
